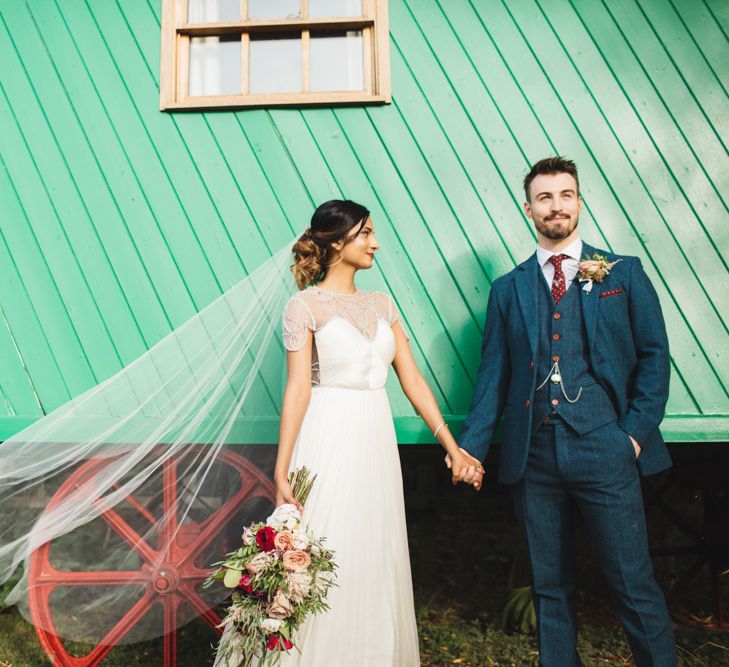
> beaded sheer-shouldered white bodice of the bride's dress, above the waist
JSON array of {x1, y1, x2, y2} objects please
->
[{"x1": 283, "y1": 287, "x2": 399, "y2": 389}]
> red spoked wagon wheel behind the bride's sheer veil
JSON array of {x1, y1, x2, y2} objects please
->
[{"x1": 28, "y1": 448, "x2": 275, "y2": 667}]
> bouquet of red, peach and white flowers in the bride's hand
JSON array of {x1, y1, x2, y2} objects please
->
[{"x1": 206, "y1": 467, "x2": 336, "y2": 667}]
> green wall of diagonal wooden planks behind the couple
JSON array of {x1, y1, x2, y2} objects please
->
[{"x1": 0, "y1": 0, "x2": 729, "y2": 442}]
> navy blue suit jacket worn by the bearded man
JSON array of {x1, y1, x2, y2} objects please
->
[{"x1": 460, "y1": 243, "x2": 671, "y2": 484}]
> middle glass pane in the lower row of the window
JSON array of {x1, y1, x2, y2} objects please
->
[{"x1": 250, "y1": 32, "x2": 301, "y2": 93}]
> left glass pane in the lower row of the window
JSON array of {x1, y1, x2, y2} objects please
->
[{"x1": 189, "y1": 35, "x2": 240, "y2": 95}]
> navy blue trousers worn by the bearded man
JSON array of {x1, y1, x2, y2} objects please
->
[{"x1": 512, "y1": 419, "x2": 676, "y2": 667}]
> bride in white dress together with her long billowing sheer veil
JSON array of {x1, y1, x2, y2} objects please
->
[{"x1": 0, "y1": 193, "x2": 483, "y2": 667}]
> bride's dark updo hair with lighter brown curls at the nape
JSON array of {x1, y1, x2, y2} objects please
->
[{"x1": 291, "y1": 199, "x2": 370, "y2": 289}]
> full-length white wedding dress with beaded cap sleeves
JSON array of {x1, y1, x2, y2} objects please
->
[{"x1": 281, "y1": 287, "x2": 420, "y2": 667}]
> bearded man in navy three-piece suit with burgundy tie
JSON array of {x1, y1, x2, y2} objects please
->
[{"x1": 460, "y1": 157, "x2": 676, "y2": 667}]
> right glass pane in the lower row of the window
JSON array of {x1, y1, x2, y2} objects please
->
[{"x1": 309, "y1": 30, "x2": 364, "y2": 91}]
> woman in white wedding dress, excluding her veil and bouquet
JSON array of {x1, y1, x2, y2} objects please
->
[{"x1": 264, "y1": 200, "x2": 483, "y2": 667}]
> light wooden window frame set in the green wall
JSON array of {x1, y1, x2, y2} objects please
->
[{"x1": 160, "y1": 0, "x2": 392, "y2": 111}]
